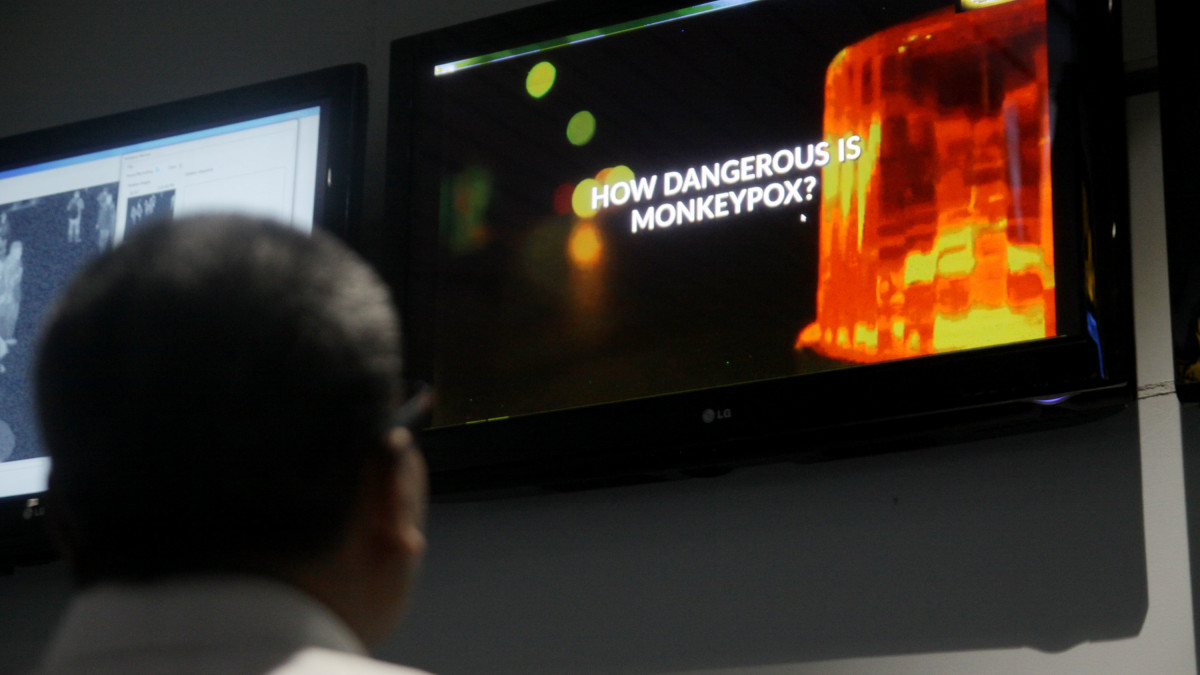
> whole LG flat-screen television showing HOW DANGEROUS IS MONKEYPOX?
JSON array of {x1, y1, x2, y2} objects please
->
[{"x1": 384, "y1": 0, "x2": 1134, "y2": 494}]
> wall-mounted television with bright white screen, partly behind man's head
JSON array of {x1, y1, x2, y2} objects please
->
[{"x1": 0, "y1": 64, "x2": 366, "y2": 565}]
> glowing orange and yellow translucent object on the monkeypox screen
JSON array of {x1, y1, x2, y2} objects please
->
[{"x1": 797, "y1": 0, "x2": 1055, "y2": 363}]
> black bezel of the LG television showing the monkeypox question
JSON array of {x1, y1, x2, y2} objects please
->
[{"x1": 384, "y1": 0, "x2": 1135, "y2": 497}]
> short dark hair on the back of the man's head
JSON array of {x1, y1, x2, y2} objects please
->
[{"x1": 35, "y1": 216, "x2": 401, "y2": 585}]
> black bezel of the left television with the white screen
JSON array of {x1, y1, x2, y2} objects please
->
[{"x1": 0, "y1": 64, "x2": 367, "y2": 569}]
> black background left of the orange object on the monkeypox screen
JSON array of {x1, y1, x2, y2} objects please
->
[{"x1": 419, "y1": 0, "x2": 1032, "y2": 425}]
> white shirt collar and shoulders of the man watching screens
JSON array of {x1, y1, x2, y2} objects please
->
[{"x1": 36, "y1": 577, "x2": 434, "y2": 675}]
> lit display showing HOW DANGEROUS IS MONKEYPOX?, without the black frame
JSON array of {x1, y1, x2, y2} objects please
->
[{"x1": 420, "y1": 0, "x2": 1056, "y2": 424}]
